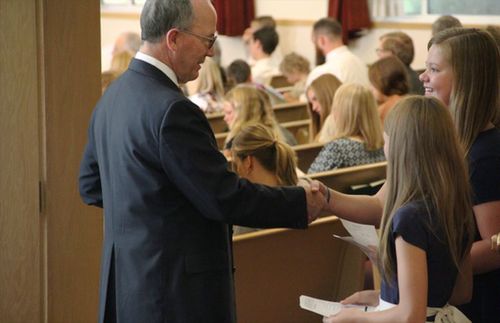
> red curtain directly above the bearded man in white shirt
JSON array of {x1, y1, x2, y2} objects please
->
[{"x1": 328, "y1": 0, "x2": 371, "y2": 44}]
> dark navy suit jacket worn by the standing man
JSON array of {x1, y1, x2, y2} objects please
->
[{"x1": 79, "y1": 60, "x2": 307, "y2": 323}]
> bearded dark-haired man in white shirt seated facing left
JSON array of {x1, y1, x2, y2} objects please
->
[{"x1": 306, "y1": 18, "x2": 370, "y2": 86}]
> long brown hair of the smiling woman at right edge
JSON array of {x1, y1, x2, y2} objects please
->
[{"x1": 427, "y1": 28, "x2": 500, "y2": 154}]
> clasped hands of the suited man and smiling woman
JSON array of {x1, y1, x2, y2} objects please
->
[{"x1": 298, "y1": 177, "x2": 332, "y2": 223}]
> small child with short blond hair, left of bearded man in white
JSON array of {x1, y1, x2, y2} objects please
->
[{"x1": 280, "y1": 53, "x2": 311, "y2": 102}]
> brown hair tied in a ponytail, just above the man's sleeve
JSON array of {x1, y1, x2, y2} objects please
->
[{"x1": 231, "y1": 124, "x2": 298, "y2": 186}]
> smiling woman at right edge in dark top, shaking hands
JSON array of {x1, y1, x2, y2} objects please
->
[{"x1": 323, "y1": 28, "x2": 500, "y2": 322}]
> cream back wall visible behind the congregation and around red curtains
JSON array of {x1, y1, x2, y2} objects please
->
[{"x1": 101, "y1": 0, "x2": 500, "y2": 70}]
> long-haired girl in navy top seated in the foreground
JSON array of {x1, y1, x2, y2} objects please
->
[{"x1": 324, "y1": 96, "x2": 474, "y2": 323}]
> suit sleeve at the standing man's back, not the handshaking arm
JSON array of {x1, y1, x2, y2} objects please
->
[{"x1": 79, "y1": 117, "x2": 102, "y2": 207}]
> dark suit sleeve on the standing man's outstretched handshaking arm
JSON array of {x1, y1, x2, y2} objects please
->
[{"x1": 159, "y1": 100, "x2": 307, "y2": 228}]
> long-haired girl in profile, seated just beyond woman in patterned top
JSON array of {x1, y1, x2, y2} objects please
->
[{"x1": 306, "y1": 74, "x2": 342, "y2": 143}]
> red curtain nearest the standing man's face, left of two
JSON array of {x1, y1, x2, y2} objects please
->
[{"x1": 213, "y1": 0, "x2": 255, "y2": 36}]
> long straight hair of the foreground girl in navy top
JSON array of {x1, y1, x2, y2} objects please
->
[{"x1": 379, "y1": 96, "x2": 474, "y2": 282}]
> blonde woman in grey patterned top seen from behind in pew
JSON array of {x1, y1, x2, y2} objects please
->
[{"x1": 308, "y1": 83, "x2": 385, "y2": 174}]
